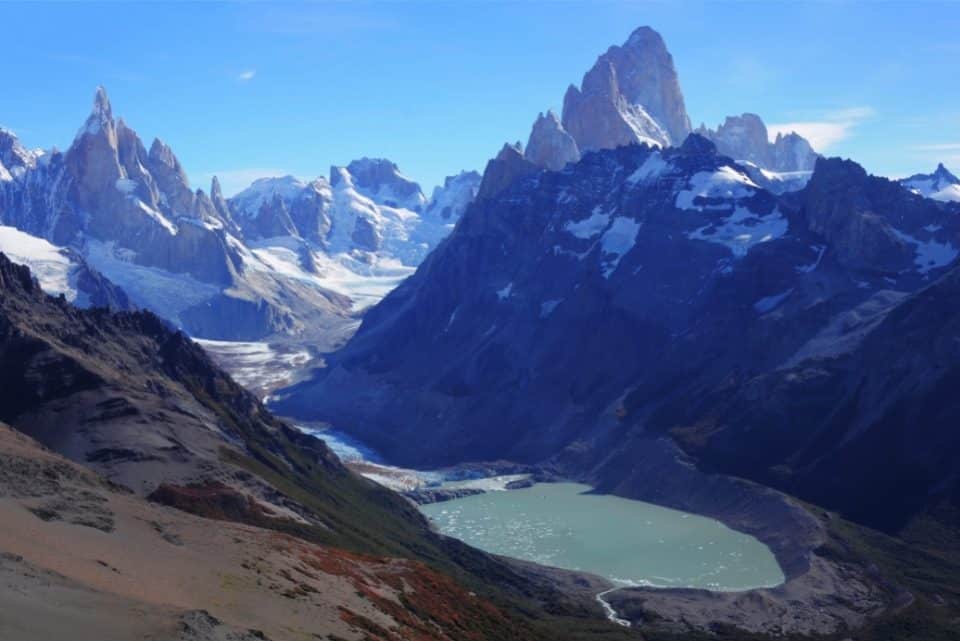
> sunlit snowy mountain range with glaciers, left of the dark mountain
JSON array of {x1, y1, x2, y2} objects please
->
[{"x1": 0, "y1": 88, "x2": 479, "y2": 345}]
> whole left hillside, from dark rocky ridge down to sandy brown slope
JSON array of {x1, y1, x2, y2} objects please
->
[{"x1": 0, "y1": 255, "x2": 632, "y2": 641}]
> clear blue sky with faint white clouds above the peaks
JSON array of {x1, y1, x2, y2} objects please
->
[{"x1": 0, "y1": 0, "x2": 960, "y2": 192}]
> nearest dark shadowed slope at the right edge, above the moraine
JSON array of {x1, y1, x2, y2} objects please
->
[{"x1": 661, "y1": 268, "x2": 960, "y2": 531}]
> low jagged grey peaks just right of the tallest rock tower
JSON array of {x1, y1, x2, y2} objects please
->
[{"x1": 697, "y1": 113, "x2": 818, "y2": 172}]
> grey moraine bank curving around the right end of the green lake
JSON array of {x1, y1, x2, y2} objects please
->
[{"x1": 300, "y1": 422, "x2": 893, "y2": 635}]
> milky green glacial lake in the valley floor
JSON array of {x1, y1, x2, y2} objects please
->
[{"x1": 420, "y1": 483, "x2": 784, "y2": 590}]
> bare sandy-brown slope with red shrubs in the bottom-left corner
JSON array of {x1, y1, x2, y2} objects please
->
[{"x1": 0, "y1": 425, "x2": 522, "y2": 641}]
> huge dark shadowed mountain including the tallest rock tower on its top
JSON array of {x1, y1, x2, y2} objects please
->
[{"x1": 276, "y1": 29, "x2": 960, "y2": 529}]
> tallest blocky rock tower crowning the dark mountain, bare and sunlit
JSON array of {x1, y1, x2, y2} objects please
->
[{"x1": 563, "y1": 27, "x2": 690, "y2": 152}]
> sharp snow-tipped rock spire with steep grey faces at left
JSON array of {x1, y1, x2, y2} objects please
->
[{"x1": 20, "y1": 87, "x2": 244, "y2": 285}]
